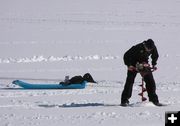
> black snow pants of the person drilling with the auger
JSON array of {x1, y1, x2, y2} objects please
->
[{"x1": 121, "y1": 70, "x2": 159, "y2": 103}]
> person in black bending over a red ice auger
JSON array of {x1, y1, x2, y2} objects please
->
[{"x1": 121, "y1": 39, "x2": 160, "y2": 106}]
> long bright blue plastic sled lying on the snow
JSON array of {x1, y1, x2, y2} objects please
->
[{"x1": 12, "y1": 80, "x2": 87, "y2": 89}]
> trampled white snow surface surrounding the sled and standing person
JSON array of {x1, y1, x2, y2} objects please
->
[{"x1": 0, "y1": 0, "x2": 180, "y2": 126}]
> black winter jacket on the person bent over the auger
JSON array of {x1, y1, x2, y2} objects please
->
[{"x1": 124, "y1": 43, "x2": 159, "y2": 66}]
